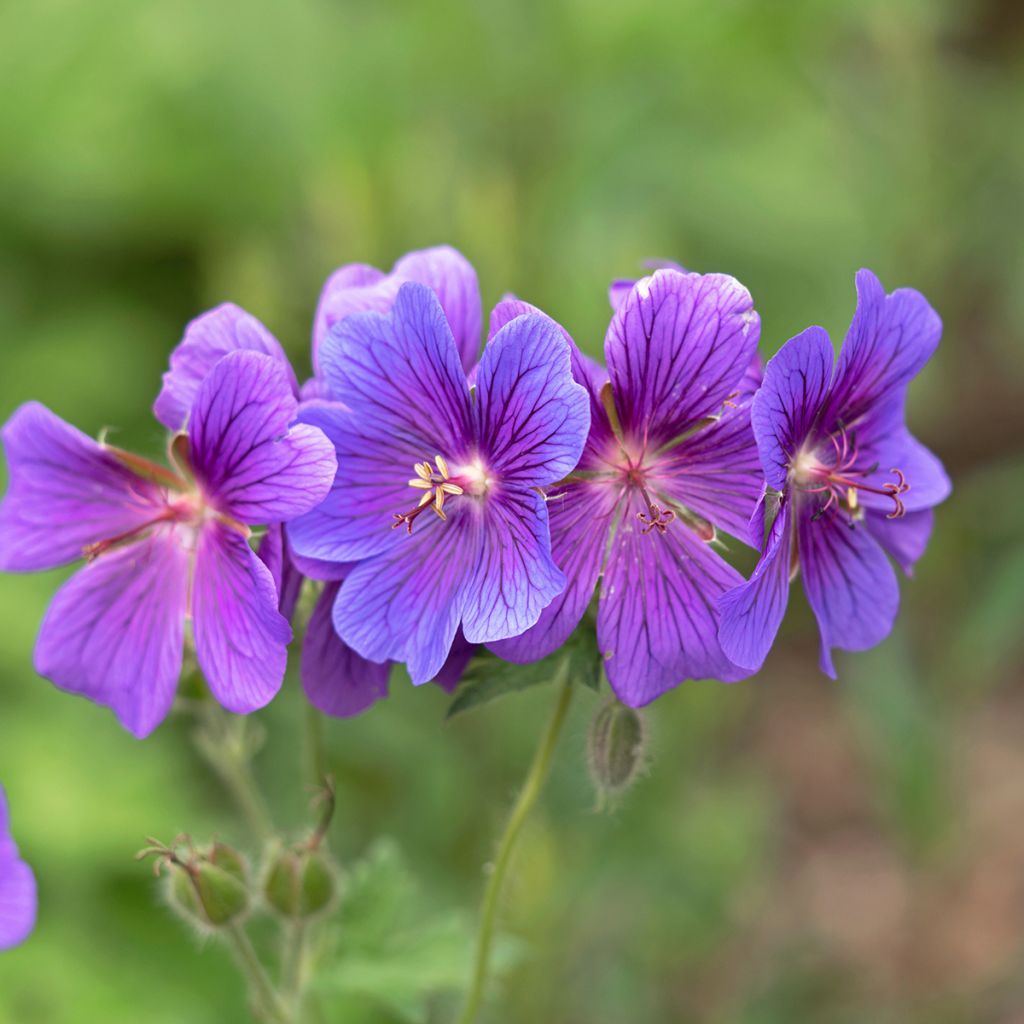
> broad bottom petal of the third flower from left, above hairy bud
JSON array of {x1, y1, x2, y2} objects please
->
[{"x1": 597, "y1": 499, "x2": 749, "y2": 708}]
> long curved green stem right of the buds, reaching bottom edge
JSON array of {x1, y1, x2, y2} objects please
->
[{"x1": 458, "y1": 677, "x2": 572, "y2": 1024}]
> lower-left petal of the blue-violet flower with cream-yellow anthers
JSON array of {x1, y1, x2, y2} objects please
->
[{"x1": 334, "y1": 502, "x2": 481, "y2": 684}]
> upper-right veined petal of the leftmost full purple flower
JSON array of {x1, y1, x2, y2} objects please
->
[{"x1": 188, "y1": 352, "x2": 338, "y2": 523}]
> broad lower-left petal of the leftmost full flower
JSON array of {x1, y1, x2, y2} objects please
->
[{"x1": 35, "y1": 528, "x2": 188, "y2": 738}]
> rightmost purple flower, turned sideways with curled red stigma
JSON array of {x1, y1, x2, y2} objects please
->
[{"x1": 721, "y1": 270, "x2": 950, "y2": 678}]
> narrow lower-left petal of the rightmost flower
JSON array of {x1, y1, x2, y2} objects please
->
[{"x1": 718, "y1": 502, "x2": 793, "y2": 672}]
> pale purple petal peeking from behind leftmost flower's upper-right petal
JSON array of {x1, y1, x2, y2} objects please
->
[{"x1": 153, "y1": 302, "x2": 299, "y2": 431}]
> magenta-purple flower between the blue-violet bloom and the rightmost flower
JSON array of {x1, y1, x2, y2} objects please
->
[{"x1": 492, "y1": 269, "x2": 760, "y2": 706}]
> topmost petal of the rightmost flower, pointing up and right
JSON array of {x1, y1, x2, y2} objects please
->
[{"x1": 823, "y1": 270, "x2": 942, "y2": 424}]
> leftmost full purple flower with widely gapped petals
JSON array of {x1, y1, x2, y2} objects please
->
[{"x1": 0, "y1": 351, "x2": 336, "y2": 736}]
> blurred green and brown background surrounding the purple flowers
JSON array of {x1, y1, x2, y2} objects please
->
[{"x1": 0, "y1": 0, "x2": 1024, "y2": 1024}]
